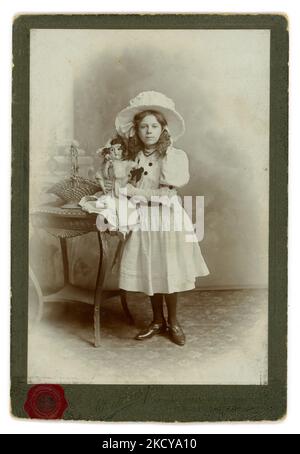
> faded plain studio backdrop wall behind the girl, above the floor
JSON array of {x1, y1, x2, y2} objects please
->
[{"x1": 30, "y1": 30, "x2": 269, "y2": 288}]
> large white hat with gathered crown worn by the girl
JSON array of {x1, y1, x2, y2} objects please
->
[{"x1": 115, "y1": 91, "x2": 185, "y2": 141}]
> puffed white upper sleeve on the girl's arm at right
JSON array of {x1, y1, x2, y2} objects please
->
[{"x1": 160, "y1": 148, "x2": 190, "y2": 188}]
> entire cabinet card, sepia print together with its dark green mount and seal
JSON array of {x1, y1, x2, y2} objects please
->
[{"x1": 12, "y1": 15, "x2": 287, "y2": 421}]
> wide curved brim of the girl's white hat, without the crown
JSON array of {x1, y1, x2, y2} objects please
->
[{"x1": 115, "y1": 104, "x2": 185, "y2": 141}]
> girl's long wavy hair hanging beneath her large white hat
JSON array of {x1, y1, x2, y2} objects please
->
[{"x1": 127, "y1": 110, "x2": 171, "y2": 160}]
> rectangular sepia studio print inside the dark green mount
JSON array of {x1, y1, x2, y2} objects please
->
[{"x1": 27, "y1": 27, "x2": 271, "y2": 385}]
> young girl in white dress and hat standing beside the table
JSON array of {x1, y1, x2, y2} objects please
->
[{"x1": 111, "y1": 91, "x2": 209, "y2": 345}]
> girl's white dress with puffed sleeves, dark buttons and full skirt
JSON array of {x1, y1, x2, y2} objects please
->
[{"x1": 119, "y1": 146, "x2": 209, "y2": 295}]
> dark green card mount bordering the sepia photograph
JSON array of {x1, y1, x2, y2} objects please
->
[{"x1": 11, "y1": 14, "x2": 288, "y2": 422}]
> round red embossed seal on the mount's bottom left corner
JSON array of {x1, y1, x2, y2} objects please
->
[{"x1": 24, "y1": 385, "x2": 68, "y2": 419}]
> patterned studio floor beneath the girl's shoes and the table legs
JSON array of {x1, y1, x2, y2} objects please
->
[{"x1": 28, "y1": 290, "x2": 268, "y2": 385}]
